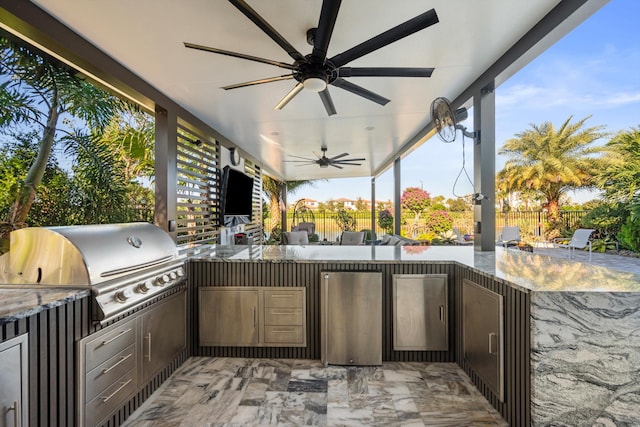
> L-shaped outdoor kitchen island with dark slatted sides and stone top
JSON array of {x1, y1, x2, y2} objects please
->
[{"x1": 188, "y1": 246, "x2": 640, "y2": 426}]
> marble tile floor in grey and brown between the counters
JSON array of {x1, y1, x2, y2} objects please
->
[{"x1": 125, "y1": 357, "x2": 507, "y2": 427}]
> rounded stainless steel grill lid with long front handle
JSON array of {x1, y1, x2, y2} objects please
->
[{"x1": 9, "y1": 223, "x2": 178, "y2": 285}]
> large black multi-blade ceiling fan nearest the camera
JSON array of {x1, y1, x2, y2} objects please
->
[{"x1": 184, "y1": 0, "x2": 438, "y2": 116}]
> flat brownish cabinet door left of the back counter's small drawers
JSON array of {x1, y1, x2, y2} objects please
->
[{"x1": 199, "y1": 288, "x2": 259, "y2": 346}]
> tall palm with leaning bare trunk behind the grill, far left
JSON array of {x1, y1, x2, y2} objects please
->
[{"x1": 0, "y1": 37, "x2": 126, "y2": 253}]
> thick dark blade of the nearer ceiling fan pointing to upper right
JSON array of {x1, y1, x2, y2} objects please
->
[{"x1": 330, "y1": 9, "x2": 438, "y2": 68}]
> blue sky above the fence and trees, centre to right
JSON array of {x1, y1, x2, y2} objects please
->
[{"x1": 296, "y1": 0, "x2": 640, "y2": 203}]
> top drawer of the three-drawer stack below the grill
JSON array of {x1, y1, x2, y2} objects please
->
[{"x1": 85, "y1": 319, "x2": 136, "y2": 372}]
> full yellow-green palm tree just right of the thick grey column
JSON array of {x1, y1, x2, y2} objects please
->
[{"x1": 498, "y1": 116, "x2": 606, "y2": 224}]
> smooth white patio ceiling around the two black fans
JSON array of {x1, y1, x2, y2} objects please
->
[{"x1": 28, "y1": 0, "x2": 600, "y2": 180}]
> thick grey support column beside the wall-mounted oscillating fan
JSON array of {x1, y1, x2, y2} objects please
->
[{"x1": 473, "y1": 83, "x2": 496, "y2": 251}]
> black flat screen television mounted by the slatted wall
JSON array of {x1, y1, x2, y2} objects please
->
[{"x1": 220, "y1": 166, "x2": 253, "y2": 227}]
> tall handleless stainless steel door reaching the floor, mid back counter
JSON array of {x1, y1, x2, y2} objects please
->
[{"x1": 320, "y1": 271, "x2": 382, "y2": 366}]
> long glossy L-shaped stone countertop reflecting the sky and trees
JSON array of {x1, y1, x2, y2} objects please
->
[{"x1": 190, "y1": 245, "x2": 640, "y2": 292}]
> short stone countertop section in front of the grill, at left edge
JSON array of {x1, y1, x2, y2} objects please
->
[{"x1": 0, "y1": 285, "x2": 91, "y2": 324}]
